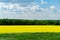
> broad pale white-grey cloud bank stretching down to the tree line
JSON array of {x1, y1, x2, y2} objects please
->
[{"x1": 0, "y1": 3, "x2": 60, "y2": 20}]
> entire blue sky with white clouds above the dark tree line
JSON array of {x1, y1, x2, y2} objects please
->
[{"x1": 0, "y1": 0, "x2": 60, "y2": 20}]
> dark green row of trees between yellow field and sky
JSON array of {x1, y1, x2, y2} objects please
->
[{"x1": 0, "y1": 19, "x2": 60, "y2": 25}]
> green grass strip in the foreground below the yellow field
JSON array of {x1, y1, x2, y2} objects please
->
[{"x1": 0, "y1": 32, "x2": 60, "y2": 40}]
